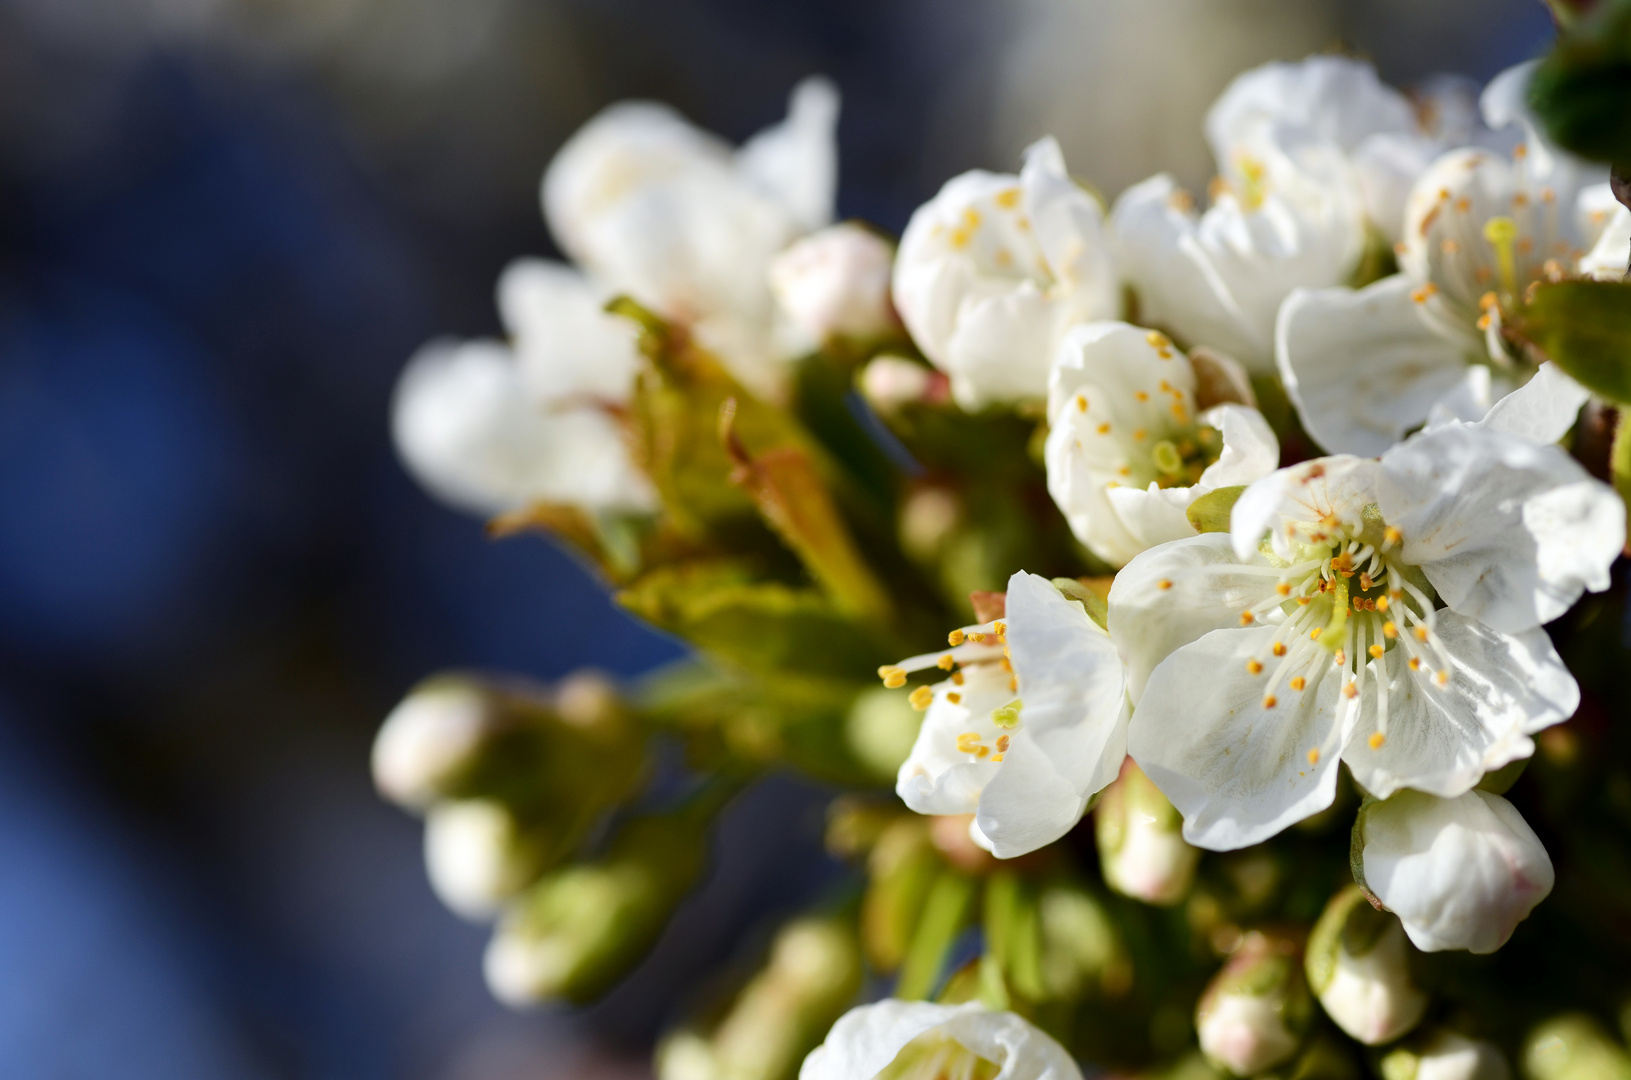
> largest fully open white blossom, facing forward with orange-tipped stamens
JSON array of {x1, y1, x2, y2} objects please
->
[{"x1": 1109, "y1": 424, "x2": 1624, "y2": 850}]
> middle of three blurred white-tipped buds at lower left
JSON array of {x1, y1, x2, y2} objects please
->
[{"x1": 424, "y1": 799, "x2": 548, "y2": 920}]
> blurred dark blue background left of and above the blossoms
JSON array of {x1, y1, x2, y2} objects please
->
[{"x1": 0, "y1": 0, "x2": 1549, "y2": 1080}]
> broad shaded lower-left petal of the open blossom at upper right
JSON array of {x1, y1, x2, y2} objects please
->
[{"x1": 1275, "y1": 274, "x2": 1476, "y2": 457}]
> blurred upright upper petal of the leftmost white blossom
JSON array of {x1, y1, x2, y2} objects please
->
[{"x1": 499, "y1": 259, "x2": 641, "y2": 403}]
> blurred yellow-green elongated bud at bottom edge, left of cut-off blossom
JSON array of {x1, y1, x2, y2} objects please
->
[{"x1": 656, "y1": 918, "x2": 861, "y2": 1080}]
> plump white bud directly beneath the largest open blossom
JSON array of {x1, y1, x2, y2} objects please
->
[{"x1": 1354, "y1": 788, "x2": 1553, "y2": 953}]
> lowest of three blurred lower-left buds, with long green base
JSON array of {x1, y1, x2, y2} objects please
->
[{"x1": 483, "y1": 814, "x2": 703, "y2": 1007}]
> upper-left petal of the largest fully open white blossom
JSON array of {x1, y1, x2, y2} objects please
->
[{"x1": 1107, "y1": 532, "x2": 1275, "y2": 705}]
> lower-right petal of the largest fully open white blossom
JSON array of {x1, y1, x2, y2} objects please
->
[{"x1": 1342, "y1": 610, "x2": 1580, "y2": 798}]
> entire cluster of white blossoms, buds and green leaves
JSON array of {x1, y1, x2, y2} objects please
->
[{"x1": 375, "y1": 42, "x2": 1631, "y2": 1080}]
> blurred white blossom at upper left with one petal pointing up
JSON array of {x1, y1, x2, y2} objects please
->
[{"x1": 541, "y1": 78, "x2": 838, "y2": 396}]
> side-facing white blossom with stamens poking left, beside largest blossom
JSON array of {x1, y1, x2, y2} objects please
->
[{"x1": 881, "y1": 571, "x2": 1127, "y2": 858}]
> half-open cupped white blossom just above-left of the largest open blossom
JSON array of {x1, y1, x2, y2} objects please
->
[{"x1": 1044, "y1": 323, "x2": 1280, "y2": 566}]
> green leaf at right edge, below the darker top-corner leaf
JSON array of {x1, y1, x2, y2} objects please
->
[{"x1": 1502, "y1": 281, "x2": 1631, "y2": 403}]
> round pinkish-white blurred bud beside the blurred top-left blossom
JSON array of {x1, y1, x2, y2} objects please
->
[{"x1": 770, "y1": 222, "x2": 899, "y2": 343}]
